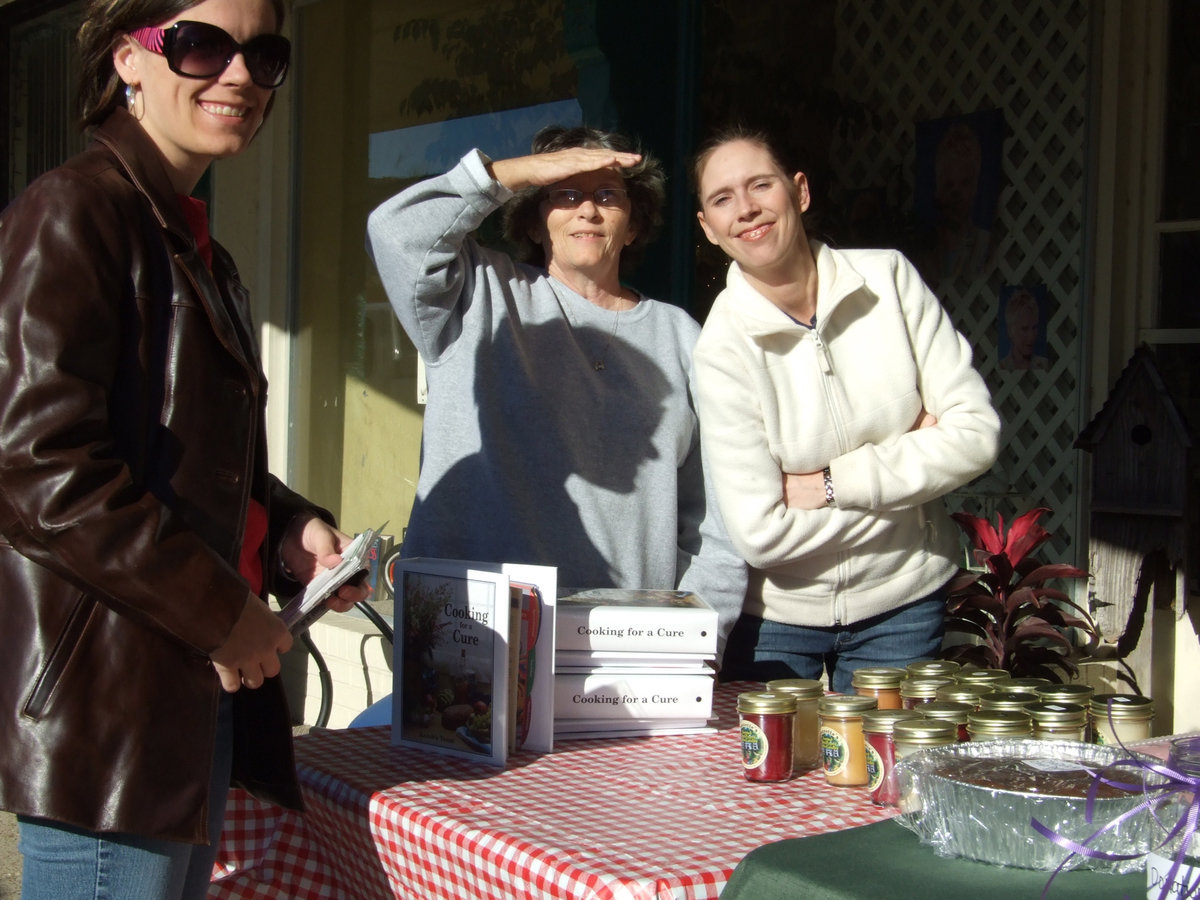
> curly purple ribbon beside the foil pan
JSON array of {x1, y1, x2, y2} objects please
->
[{"x1": 1030, "y1": 700, "x2": 1200, "y2": 900}]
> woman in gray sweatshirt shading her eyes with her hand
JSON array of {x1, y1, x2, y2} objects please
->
[{"x1": 368, "y1": 126, "x2": 745, "y2": 662}]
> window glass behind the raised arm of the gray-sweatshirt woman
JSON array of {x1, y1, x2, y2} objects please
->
[{"x1": 289, "y1": 0, "x2": 580, "y2": 539}]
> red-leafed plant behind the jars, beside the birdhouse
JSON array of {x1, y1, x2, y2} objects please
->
[{"x1": 942, "y1": 508, "x2": 1100, "y2": 682}]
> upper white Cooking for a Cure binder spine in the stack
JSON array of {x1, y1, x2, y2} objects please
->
[{"x1": 554, "y1": 604, "x2": 716, "y2": 654}]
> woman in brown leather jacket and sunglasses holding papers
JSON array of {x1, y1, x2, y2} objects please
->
[{"x1": 0, "y1": 0, "x2": 366, "y2": 900}]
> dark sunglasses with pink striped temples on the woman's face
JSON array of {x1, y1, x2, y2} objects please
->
[{"x1": 130, "y1": 22, "x2": 292, "y2": 89}]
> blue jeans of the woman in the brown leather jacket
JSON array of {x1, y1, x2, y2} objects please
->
[{"x1": 17, "y1": 695, "x2": 233, "y2": 900}]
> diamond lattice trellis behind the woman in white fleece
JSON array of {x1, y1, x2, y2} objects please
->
[{"x1": 830, "y1": 0, "x2": 1088, "y2": 564}]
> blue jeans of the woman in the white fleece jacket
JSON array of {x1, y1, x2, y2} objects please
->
[{"x1": 721, "y1": 587, "x2": 946, "y2": 694}]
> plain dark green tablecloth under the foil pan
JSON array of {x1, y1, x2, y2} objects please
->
[{"x1": 721, "y1": 821, "x2": 1146, "y2": 900}]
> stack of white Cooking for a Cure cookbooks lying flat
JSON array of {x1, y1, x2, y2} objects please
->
[{"x1": 554, "y1": 588, "x2": 716, "y2": 739}]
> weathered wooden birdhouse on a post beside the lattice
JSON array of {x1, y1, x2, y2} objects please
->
[{"x1": 1075, "y1": 347, "x2": 1200, "y2": 727}]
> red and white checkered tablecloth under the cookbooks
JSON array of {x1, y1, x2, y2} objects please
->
[{"x1": 210, "y1": 684, "x2": 890, "y2": 900}]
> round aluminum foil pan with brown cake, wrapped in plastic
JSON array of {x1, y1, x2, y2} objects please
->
[{"x1": 895, "y1": 739, "x2": 1165, "y2": 874}]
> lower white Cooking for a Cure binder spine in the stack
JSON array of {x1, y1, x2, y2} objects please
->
[{"x1": 554, "y1": 674, "x2": 714, "y2": 720}]
